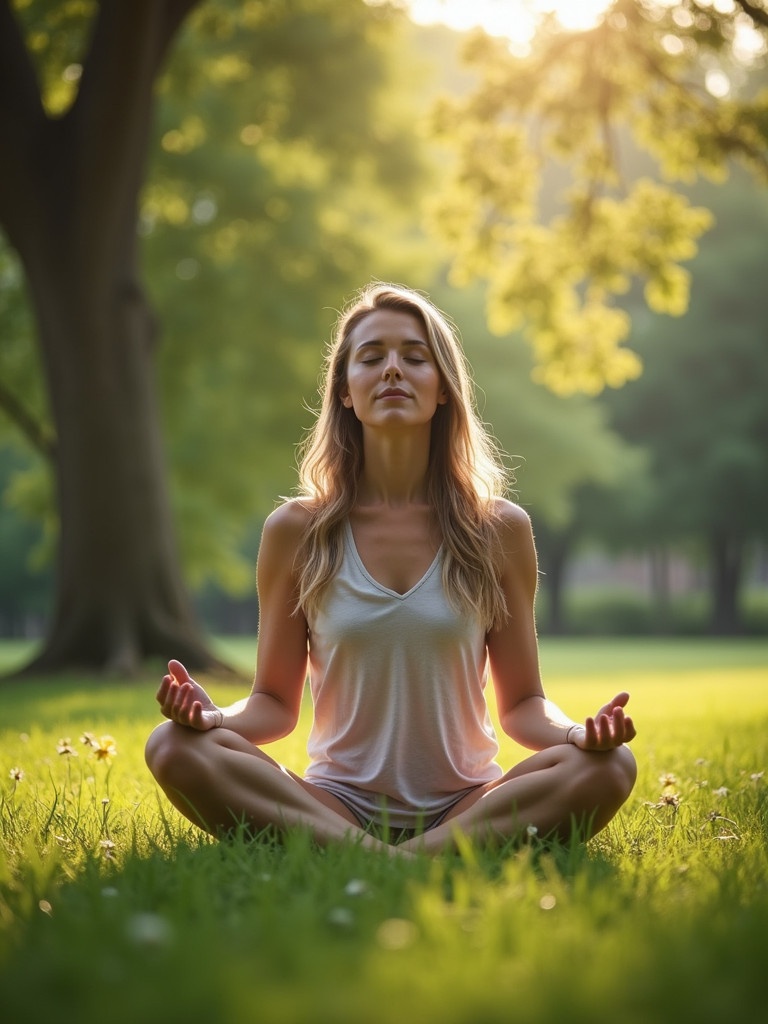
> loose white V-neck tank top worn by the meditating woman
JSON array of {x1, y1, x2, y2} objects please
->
[{"x1": 306, "y1": 522, "x2": 502, "y2": 828}]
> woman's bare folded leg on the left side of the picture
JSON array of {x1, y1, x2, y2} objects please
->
[{"x1": 145, "y1": 722, "x2": 394, "y2": 853}]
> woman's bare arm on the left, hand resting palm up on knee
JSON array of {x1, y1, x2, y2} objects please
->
[{"x1": 158, "y1": 502, "x2": 307, "y2": 744}]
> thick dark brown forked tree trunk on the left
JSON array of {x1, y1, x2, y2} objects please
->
[{"x1": 0, "y1": 0, "x2": 231, "y2": 674}]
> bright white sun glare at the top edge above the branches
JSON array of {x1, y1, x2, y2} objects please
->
[{"x1": 410, "y1": 0, "x2": 609, "y2": 45}]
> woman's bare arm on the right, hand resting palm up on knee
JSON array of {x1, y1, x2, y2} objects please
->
[{"x1": 487, "y1": 502, "x2": 635, "y2": 751}]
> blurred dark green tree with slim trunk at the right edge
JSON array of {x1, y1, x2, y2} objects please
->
[{"x1": 605, "y1": 169, "x2": 768, "y2": 633}]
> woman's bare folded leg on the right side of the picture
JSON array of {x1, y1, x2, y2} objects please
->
[{"x1": 401, "y1": 744, "x2": 637, "y2": 853}]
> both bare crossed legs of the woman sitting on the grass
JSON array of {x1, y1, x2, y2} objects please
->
[{"x1": 146, "y1": 722, "x2": 636, "y2": 853}]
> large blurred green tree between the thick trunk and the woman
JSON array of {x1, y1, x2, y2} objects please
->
[{"x1": 147, "y1": 0, "x2": 430, "y2": 593}]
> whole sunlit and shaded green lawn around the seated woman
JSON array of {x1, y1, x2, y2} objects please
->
[{"x1": 0, "y1": 639, "x2": 768, "y2": 1024}]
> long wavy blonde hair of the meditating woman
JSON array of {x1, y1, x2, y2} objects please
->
[{"x1": 298, "y1": 284, "x2": 507, "y2": 629}]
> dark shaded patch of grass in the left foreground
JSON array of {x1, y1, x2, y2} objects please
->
[{"x1": 0, "y1": 833, "x2": 428, "y2": 1022}]
